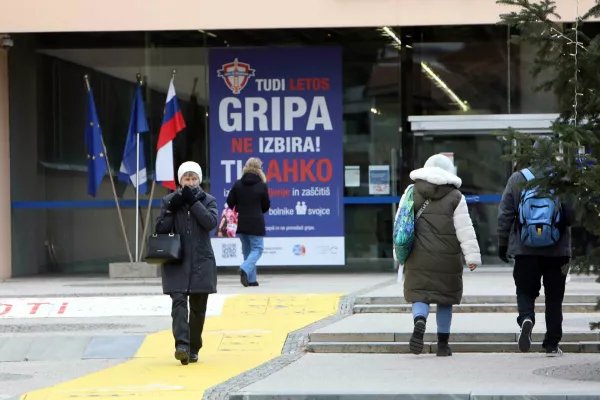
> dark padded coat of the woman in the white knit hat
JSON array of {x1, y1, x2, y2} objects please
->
[{"x1": 156, "y1": 191, "x2": 217, "y2": 294}]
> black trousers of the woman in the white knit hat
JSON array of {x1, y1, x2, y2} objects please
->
[{"x1": 171, "y1": 293, "x2": 208, "y2": 354}]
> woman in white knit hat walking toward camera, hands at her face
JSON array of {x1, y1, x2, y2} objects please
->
[{"x1": 156, "y1": 161, "x2": 217, "y2": 365}]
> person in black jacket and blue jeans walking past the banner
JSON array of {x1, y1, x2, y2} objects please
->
[{"x1": 227, "y1": 157, "x2": 271, "y2": 287}]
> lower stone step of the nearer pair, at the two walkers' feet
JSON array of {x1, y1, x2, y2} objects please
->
[{"x1": 307, "y1": 339, "x2": 600, "y2": 354}]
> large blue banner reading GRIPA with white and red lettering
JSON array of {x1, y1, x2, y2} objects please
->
[{"x1": 209, "y1": 47, "x2": 345, "y2": 266}]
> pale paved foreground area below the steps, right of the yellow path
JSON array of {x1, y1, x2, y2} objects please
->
[{"x1": 232, "y1": 354, "x2": 600, "y2": 400}]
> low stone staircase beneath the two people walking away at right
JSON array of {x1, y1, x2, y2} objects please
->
[{"x1": 307, "y1": 284, "x2": 600, "y2": 353}]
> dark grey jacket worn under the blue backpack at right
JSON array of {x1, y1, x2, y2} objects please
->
[{"x1": 498, "y1": 171, "x2": 571, "y2": 257}]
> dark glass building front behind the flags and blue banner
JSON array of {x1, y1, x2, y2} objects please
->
[{"x1": 9, "y1": 26, "x2": 556, "y2": 276}]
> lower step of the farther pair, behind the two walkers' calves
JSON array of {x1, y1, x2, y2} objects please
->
[{"x1": 353, "y1": 299, "x2": 598, "y2": 314}]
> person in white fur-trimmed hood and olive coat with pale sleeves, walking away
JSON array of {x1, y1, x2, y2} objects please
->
[{"x1": 394, "y1": 154, "x2": 481, "y2": 357}]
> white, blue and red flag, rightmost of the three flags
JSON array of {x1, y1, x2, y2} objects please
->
[{"x1": 156, "y1": 79, "x2": 185, "y2": 190}]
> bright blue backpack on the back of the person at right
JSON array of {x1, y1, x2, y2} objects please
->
[{"x1": 519, "y1": 168, "x2": 562, "y2": 247}]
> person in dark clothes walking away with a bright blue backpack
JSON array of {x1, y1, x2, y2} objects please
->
[{"x1": 498, "y1": 137, "x2": 571, "y2": 357}]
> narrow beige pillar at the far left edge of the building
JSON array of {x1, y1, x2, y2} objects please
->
[{"x1": 0, "y1": 49, "x2": 12, "y2": 280}]
